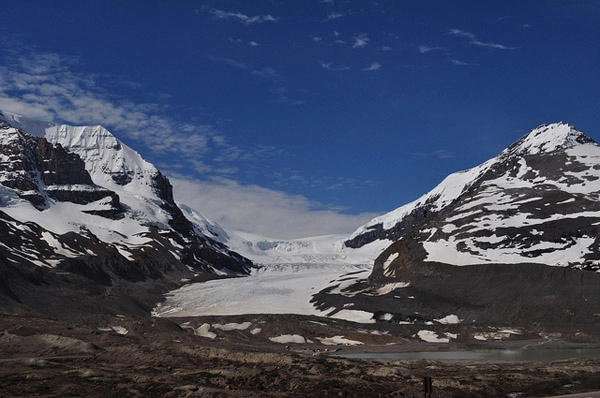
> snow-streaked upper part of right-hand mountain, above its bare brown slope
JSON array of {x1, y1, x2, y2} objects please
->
[{"x1": 346, "y1": 123, "x2": 600, "y2": 276}]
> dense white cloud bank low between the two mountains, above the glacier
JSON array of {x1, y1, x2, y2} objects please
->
[{"x1": 169, "y1": 177, "x2": 377, "y2": 239}]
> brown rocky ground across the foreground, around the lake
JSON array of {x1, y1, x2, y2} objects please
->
[{"x1": 0, "y1": 315, "x2": 600, "y2": 397}]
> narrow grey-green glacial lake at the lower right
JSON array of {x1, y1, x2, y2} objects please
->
[{"x1": 336, "y1": 348, "x2": 600, "y2": 362}]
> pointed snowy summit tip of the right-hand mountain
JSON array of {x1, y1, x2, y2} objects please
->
[{"x1": 500, "y1": 122, "x2": 596, "y2": 156}]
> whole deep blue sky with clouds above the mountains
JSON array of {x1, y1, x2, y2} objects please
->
[{"x1": 0, "y1": 0, "x2": 600, "y2": 238}]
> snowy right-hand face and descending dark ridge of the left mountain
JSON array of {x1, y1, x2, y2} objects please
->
[{"x1": 45, "y1": 125, "x2": 252, "y2": 274}]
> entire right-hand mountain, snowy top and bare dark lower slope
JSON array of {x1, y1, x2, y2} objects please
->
[{"x1": 316, "y1": 123, "x2": 600, "y2": 326}]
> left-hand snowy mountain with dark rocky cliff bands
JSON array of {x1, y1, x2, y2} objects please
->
[{"x1": 0, "y1": 112, "x2": 252, "y2": 320}]
